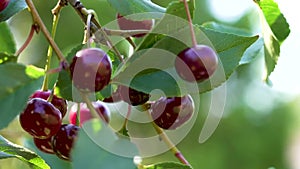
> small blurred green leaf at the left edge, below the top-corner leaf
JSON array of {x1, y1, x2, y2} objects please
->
[{"x1": 0, "y1": 21, "x2": 16, "y2": 54}]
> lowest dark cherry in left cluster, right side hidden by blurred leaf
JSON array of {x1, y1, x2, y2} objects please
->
[{"x1": 52, "y1": 124, "x2": 79, "y2": 160}]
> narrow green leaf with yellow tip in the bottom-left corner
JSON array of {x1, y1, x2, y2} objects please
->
[{"x1": 0, "y1": 135, "x2": 50, "y2": 169}]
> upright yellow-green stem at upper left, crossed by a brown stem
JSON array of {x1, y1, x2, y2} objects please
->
[{"x1": 42, "y1": 1, "x2": 62, "y2": 91}]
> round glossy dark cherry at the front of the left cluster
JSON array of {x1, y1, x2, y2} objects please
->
[{"x1": 19, "y1": 98, "x2": 62, "y2": 139}]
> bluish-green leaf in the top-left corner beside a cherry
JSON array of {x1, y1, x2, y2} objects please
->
[{"x1": 0, "y1": 0, "x2": 27, "y2": 22}]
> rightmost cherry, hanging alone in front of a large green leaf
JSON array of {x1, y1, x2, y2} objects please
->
[{"x1": 175, "y1": 45, "x2": 218, "y2": 82}]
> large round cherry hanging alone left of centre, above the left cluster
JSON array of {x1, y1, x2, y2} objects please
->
[{"x1": 70, "y1": 48, "x2": 112, "y2": 92}]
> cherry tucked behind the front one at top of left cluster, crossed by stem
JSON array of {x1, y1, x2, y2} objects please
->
[{"x1": 30, "y1": 90, "x2": 68, "y2": 118}]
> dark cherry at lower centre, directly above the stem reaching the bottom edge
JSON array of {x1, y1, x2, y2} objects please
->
[{"x1": 151, "y1": 95, "x2": 194, "y2": 129}]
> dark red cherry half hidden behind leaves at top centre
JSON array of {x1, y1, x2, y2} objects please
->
[{"x1": 117, "y1": 13, "x2": 154, "y2": 37}]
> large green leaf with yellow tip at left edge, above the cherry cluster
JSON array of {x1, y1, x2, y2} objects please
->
[{"x1": 0, "y1": 63, "x2": 43, "y2": 129}]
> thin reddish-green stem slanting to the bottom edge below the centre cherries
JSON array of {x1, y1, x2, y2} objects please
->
[{"x1": 147, "y1": 112, "x2": 191, "y2": 166}]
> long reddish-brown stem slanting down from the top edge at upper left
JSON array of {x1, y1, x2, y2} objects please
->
[{"x1": 25, "y1": 0, "x2": 66, "y2": 62}]
